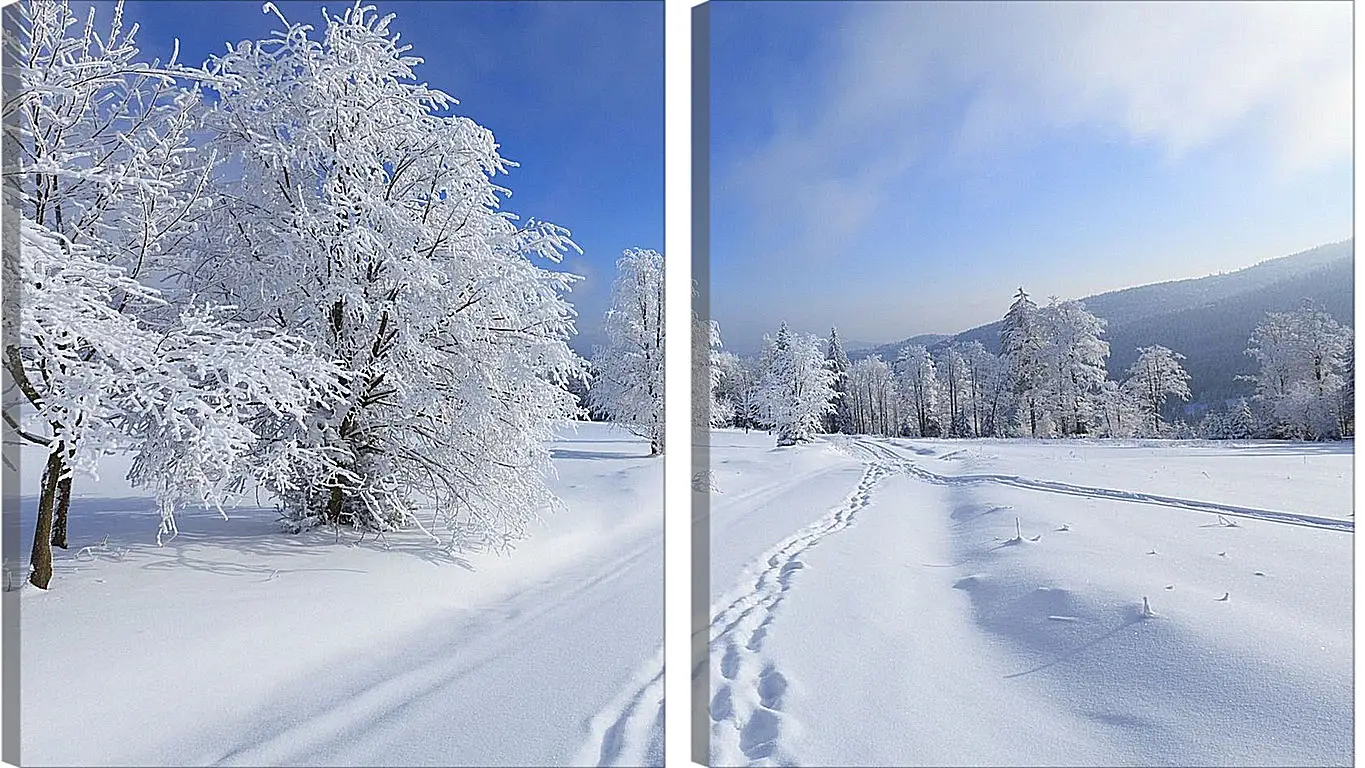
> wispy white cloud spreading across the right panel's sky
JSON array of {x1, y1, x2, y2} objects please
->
[{"x1": 715, "y1": 0, "x2": 1353, "y2": 259}]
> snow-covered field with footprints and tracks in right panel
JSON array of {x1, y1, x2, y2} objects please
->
[{"x1": 710, "y1": 430, "x2": 1354, "y2": 765}]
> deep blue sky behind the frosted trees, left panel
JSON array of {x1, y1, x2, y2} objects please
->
[{"x1": 110, "y1": 0, "x2": 663, "y2": 352}]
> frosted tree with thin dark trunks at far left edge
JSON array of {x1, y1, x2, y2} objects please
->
[{"x1": 4, "y1": 1, "x2": 340, "y2": 588}]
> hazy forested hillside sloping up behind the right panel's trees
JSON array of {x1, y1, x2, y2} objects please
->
[{"x1": 850, "y1": 240, "x2": 1355, "y2": 404}]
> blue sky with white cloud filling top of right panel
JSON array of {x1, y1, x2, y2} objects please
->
[{"x1": 711, "y1": 0, "x2": 1353, "y2": 352}]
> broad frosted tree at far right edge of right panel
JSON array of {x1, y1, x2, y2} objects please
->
[{"x1": 1246, "y1": 303, "x2": 1354, "y2": 439}]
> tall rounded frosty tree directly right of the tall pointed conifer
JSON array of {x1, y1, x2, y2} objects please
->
[{"x1": 1037, "y1": 299, "x2": 1108, "y2": 435}]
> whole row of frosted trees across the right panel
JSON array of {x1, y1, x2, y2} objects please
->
[{"x1": 706, "y1": 288, "x2": 1354, "y2": 445}]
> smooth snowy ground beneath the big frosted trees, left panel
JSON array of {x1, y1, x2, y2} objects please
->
[{"x1": 20, "y1": 424, "x2": 663, "y2": 765}]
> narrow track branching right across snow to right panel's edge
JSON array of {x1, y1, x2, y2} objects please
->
[{"x1": 853, "y1": 438, "x2": 1355, "y2": 533}]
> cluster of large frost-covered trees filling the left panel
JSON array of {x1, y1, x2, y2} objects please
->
[{"x1": 4, "y1": 0, "x2": 581, "y2": 587}]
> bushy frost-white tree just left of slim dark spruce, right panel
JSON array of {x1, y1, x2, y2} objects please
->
[{"x1": 760, "y1": 322, "x2": 834, "y2": 446}]
